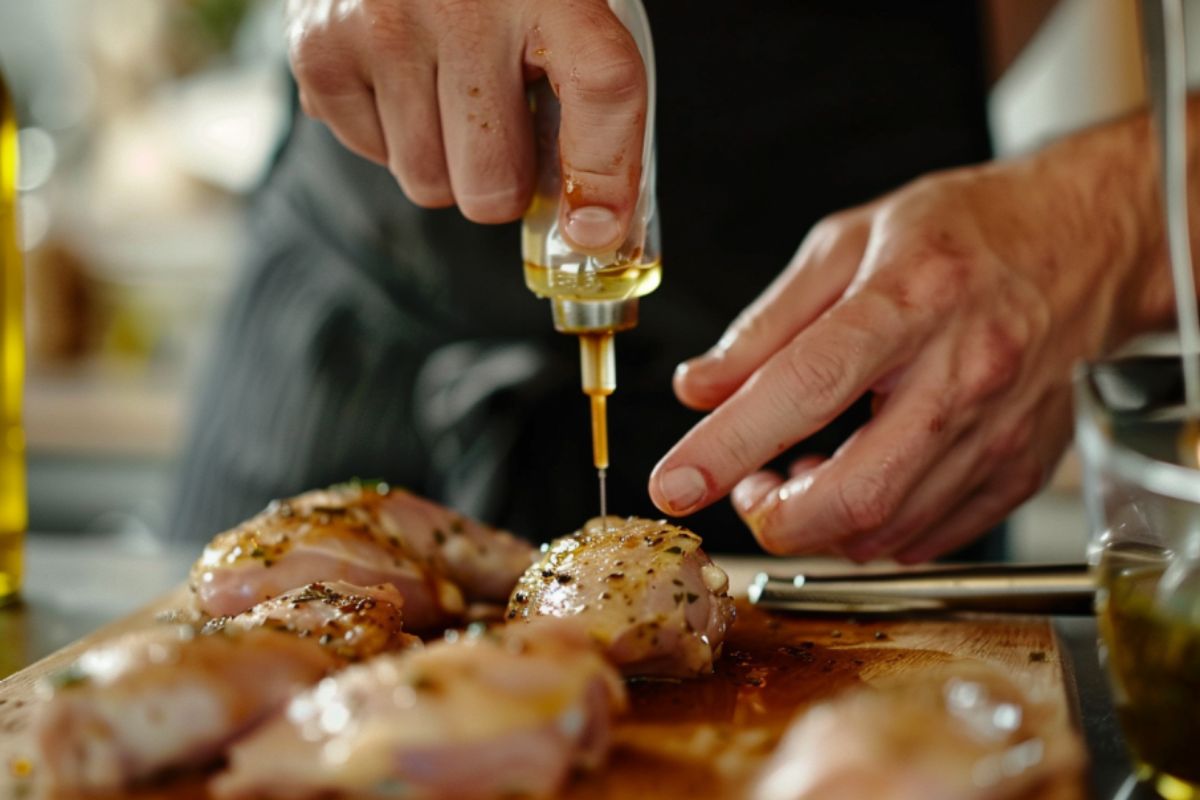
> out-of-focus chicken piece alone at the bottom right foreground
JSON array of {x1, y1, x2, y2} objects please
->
[{"x1": 754, "y1": 667, "x2": 1084, "y2": 800}]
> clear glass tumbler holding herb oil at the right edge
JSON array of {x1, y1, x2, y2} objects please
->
[{"x1": 1075, "y1": 356, "x2": 1200, "y2": 800}]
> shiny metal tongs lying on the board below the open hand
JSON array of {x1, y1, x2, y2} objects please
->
[{"x1": 746, "y1": 564, "x2": 1096, "y2": 614}]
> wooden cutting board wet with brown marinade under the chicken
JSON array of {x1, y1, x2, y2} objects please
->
[{"x1": 0, "y1": 590, "x2": 1084, "y2": 800}]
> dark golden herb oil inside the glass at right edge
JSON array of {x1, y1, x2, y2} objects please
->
[{"x1": 1097, "y1": 545, "x2": 1200, "y2": 800}]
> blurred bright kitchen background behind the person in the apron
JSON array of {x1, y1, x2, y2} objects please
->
[{"x1": 0, "y1": 0, "x2": 1200, "y2": 559}]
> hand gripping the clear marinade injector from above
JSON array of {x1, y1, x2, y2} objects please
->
[{"x1": 287, "y1": 0, "x2": 646, "y2": 249}]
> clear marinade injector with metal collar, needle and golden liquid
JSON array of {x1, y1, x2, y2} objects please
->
[{"x1": 521, "y1": 0, "x2": 662, "y2": 525}]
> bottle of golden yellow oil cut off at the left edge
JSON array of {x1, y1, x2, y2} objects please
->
[{"x1": 0, "y1": 76, "x2": 28, "y2": 604}]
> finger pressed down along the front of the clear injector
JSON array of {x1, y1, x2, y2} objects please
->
[{"x1": 527, "y1": 0, "x2": 647, "y2": 252}]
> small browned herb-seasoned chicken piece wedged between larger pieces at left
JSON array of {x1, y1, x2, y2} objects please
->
[{"x1": 204, "y1": 581, "x2": 421, "y2": 661}]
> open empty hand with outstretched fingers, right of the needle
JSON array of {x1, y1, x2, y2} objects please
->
[{"x1": 650, "y1": 113, "x2": 1170, "y2": 561}]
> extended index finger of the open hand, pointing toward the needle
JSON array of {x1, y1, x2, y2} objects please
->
[{"x1": 650, "y1": 290, "x2": 924, "y2": 515}]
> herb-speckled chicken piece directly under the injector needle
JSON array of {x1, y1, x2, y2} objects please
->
[{"x1": 508, "y1": 517, "x2": 734, "y2": 678}]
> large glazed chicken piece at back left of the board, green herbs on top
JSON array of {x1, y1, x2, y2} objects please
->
[{"x1": 191, "y1": 483, "x2": 534, "y2": 630}]
